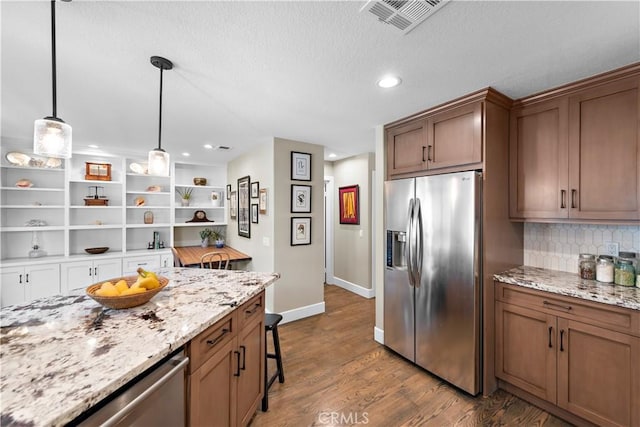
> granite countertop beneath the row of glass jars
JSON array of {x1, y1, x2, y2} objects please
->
[{"x1": 493, "y1": 266, "x2": 640, "y2": 310}]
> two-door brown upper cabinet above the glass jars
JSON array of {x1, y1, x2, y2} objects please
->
[{"x1": 510, "y1": 66, "x2": 640, "y2": 222}]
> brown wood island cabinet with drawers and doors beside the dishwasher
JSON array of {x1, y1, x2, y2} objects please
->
[{"x1": 188, "y1": 292, "x2": 265, "y2": 426}]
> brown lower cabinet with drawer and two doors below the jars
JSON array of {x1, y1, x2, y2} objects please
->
[{"x1": 495, "y1": 283, "x2": 640, "y2": 426}]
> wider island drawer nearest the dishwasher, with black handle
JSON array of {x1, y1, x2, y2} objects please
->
[{"x1": 189, "y1": 311, "x2": 238, "y2": 372}]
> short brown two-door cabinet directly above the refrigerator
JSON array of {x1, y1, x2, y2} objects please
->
[{"x1": 385, "y1": 89, "x2": 496, "y2": 179}]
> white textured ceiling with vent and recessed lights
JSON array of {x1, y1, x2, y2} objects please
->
[{"x1": 0, "y1": 0, "x2": 640, "y2": 163}]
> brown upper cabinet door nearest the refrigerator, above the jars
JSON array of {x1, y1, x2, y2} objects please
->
[{"x1": 509, "y1": 99, "x2": 570, "y2": 218}]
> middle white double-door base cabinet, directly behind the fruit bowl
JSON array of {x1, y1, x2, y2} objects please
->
[{"x1": 60, "y1": 258, "x2": 122, "y2": 294}]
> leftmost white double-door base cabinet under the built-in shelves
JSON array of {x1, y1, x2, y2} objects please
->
[{"x1": 0, "y1": 264, "x2": 60, "y2": 307}]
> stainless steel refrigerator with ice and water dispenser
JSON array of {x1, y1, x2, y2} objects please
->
[{"x1": 384, "y1": 171, "x2": 482, "y2": 395}]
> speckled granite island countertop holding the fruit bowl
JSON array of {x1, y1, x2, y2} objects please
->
[{"x1": 0, "y1": 268, "x2": 280, "y2": 426}]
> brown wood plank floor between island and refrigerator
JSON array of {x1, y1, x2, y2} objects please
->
[{"x1": 251, "y1": 285, "x2": 569, "y2": 427}]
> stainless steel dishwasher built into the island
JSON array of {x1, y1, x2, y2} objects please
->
[{"x1": 71, "y1": 351, "x2": 189, "y2": 427}]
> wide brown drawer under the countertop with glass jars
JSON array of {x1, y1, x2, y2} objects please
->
[{"x1": 496, "y1": 282, "x2": 640, "y2": 336}]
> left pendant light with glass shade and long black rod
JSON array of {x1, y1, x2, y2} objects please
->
[{"x1": 33, "y1": 0, "x2": 71, "y2": 159}]
